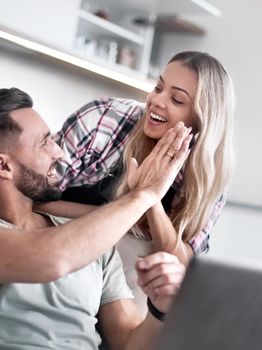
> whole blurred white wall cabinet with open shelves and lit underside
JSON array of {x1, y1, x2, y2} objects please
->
[{"x1": 0, "y1": 0, "x2": 219, "y2": 91}]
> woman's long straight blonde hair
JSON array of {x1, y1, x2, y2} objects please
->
[{"x1": 116, "y1": 51, "x2": 235, "y2": 242}]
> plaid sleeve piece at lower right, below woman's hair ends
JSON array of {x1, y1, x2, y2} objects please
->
[{"x1": 188, "y1": 190, "x2": 227, "y2": 254}]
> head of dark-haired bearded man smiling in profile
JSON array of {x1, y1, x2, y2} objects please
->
[{"x1": 0, "y1": 88, "x2": 62, "y2": 202}]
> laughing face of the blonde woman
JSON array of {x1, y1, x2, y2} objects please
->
[{"x1": 144, "y1": 61, "x2": 196, "y2": 140}]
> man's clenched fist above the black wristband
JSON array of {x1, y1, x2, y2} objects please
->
[{"x1": 136, "y1": 252, "x2": 185, "y2": 312}]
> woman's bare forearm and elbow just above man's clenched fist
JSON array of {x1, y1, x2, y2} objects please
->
[{"x1": 146, "y1": 202, "x2": 193, "y2": 265}]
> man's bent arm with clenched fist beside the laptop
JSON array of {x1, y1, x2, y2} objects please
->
[{"x1": 99, "y1": 252, "x2": 185, "y2": 350}]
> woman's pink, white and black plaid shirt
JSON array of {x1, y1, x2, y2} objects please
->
[{"x1": 55, "y1": 98, "x2": 225, "y2": 254}]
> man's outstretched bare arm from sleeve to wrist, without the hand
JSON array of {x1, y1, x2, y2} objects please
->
[{"x1": 0, "y1": 190, "x2": 154, "y2": 283}]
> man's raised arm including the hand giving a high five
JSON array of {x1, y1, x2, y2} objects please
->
[{"x1": 0, "y1": 130, "x2": 188, "y2": 283}]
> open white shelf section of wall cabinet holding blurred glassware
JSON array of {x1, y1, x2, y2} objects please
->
[{"x1": 74, "y1": 0, "x2": 155, "y2": 79}]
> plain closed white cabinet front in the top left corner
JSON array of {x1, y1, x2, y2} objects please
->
[{"x1": 0, "y1": 0, "x2": 80, "y2": 51}]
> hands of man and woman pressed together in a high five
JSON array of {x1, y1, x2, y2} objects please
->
[{"x1": 127, "y1": 122, "x2": 192, "y2": 200}]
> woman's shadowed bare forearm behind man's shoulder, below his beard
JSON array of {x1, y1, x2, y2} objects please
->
[{"x1": 33, "y1": 201, "x2": 97, "y2": 219}]
